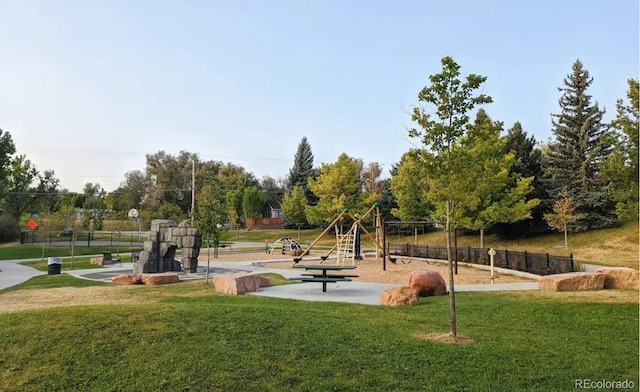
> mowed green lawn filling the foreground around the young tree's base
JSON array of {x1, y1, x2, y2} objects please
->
[{"x1": 0, "y1": 283, "x2": 639, "y2": 392}]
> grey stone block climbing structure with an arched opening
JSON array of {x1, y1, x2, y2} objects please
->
[{"x1": 133, "y1": 219, "x2": 202, "y2": 274}]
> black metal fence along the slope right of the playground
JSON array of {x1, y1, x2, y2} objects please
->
[{"x1": 389, "y1": 244, "x2": 574, "y2": 275}]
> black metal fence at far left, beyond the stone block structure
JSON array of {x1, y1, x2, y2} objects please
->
[{"x1": 20, "y1": 230, "x2": 147, "y2": 246}]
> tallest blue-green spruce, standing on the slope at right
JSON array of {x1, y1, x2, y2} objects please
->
[{"x1": 543, "y1": 60, "x2": 617, "y2": 231}]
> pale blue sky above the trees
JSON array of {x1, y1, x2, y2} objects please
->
[{"x1": 0, "y1": 0, "x2": 639, "y2": 191}]
